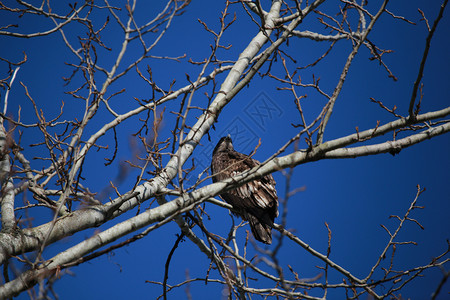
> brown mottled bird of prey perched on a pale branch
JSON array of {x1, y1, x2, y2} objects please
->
[{"x1": 211, "y1": 135, "x2": 278, "y2": 245}]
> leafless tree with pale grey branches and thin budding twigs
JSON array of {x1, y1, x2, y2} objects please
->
[{"x1": 0, "y1": 0, "x2": 450, "y2": 299}]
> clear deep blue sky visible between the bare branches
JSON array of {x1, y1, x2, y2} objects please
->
[{"x1": 0, "y1": 1, "x2": 450, "y2": 299}]
